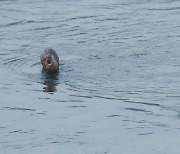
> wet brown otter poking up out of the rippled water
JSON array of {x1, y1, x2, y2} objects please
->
[{"x1": 40, "y1": 48, "x2": 59, "y2": 73}]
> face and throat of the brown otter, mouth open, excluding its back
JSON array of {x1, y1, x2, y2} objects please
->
[{"x1": 42, "y1": 54, "x2": 59, "y2": 73}]
